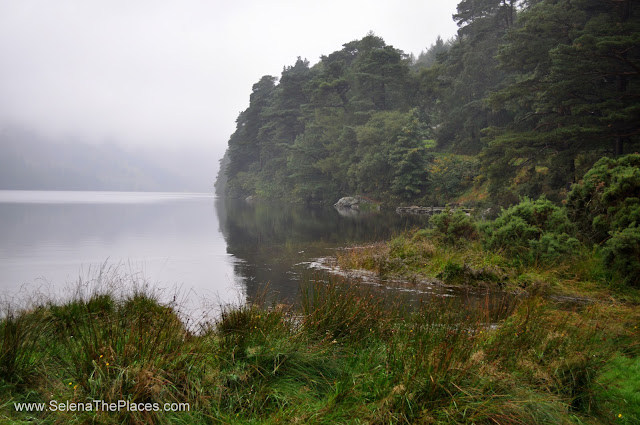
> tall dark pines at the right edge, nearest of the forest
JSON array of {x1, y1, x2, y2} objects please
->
[{"x1": 482, "y1": 0, "x2": 640, "y2": 202}]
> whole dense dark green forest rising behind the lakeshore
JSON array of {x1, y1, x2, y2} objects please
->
[{"x1": 217, "y1": 0, "x2": 640, "y2": 205}]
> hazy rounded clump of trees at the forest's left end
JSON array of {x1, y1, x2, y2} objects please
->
[{"x1": 223, "y1": 34, "x2": 427, "y2": 203}]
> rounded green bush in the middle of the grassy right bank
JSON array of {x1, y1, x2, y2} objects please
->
[{"x1": 483, "y1": 198, "x2": 580, "y2": 263}]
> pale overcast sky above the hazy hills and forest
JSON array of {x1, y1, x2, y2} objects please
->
[{"x1": 0, "y1": 0, "x2": 458, "y2": 159}]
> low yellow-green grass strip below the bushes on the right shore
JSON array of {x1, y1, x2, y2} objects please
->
[{"x1": 336, "y1": 229, "x2": 612, "y2": 302}]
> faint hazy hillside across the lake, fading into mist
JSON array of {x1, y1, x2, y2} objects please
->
[{"x1": 0, "y1": 126, "x2": 211, "y2": 192}]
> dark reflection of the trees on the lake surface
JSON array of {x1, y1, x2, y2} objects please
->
[{"x1": 215, "y1": 199, "x2": 424, "y2": 300}]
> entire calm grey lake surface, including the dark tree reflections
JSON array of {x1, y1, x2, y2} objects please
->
[{"x1": 0, "y1": 191, "x2": 500, "y2": 314}]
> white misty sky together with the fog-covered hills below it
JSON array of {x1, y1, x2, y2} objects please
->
[{"x1": 0, "y1": 0, "x2": 456, "y2": 191}]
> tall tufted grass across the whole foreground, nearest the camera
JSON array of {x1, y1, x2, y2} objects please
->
[{"x1": 0, "y1": 266, "x2": 640, "y2": 424}]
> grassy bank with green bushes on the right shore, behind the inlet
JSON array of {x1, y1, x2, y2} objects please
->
[{"x1": 337, "y1": 194, "x2": 640, "y2": 303}]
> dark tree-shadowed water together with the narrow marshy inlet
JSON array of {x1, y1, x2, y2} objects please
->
[{"x1": 215, "y1": 199, "x2": 504, "y2": 311}]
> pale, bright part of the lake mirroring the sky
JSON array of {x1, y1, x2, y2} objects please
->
[{"x1": 0, "y1": 191, "x2": 244, "y2": 310}]
